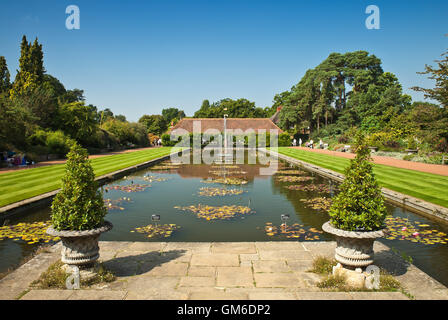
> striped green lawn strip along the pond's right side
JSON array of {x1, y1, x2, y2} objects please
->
[{"x1": 278, "y1": 147, "x2": 448, "y2": 207}]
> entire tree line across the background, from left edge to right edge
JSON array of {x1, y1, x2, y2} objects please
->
[{"x1": 0, "y1": 36, "x2": 448, "y2": 160}]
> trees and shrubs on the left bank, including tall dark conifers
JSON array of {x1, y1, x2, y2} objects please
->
[{"x1": 0, "y1": 36, "x2": 189, "y2": 160}]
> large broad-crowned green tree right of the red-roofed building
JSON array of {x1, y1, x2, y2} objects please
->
[{"x1": 274, "y1": 51, "x2": 411, "y2": 134}]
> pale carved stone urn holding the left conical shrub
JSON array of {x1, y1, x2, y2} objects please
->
[{"x1": 47, "y1": 221, "x2": 113, "y2": 267}]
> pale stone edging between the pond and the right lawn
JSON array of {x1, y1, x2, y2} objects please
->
[{"x1": 258, "y1": 149, "x2": 448, "y2": 223}]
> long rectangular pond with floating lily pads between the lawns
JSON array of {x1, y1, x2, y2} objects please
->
[{"x1": 0, "y1": 151, "x2": 448, "y2": 286}]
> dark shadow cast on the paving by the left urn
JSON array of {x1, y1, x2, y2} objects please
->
[{"x1": 103, "y1": 250, "x2": 187, "y2": 277}]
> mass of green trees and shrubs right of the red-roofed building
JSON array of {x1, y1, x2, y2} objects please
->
[{"x1": 274, "y1": 51, "x2": 448, "y2": 152}]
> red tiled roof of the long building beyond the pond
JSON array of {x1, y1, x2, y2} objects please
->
[{"x1": 170, "y1": 118, "x2": 283, "y2": 133}]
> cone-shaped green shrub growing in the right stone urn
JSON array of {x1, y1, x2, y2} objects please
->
[{"x1": 329, "y1": 133, "x2": 387, "y2": 231}]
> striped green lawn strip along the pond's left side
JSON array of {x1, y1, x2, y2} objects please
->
[{"x1": 0, "y1": 147, "x2": 172, "y2": 207}]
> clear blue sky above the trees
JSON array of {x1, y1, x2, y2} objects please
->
[{"x1": 0, "y1": 0, "x2": 448, "y2": 121}]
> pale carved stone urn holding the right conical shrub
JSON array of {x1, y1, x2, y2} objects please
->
[{"x1": 322, "y1": 221, "x2": 384, "y2": 269}]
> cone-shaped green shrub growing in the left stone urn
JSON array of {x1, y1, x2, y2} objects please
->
[{"x1": 51, "y1": 143, "x2": 107, "y2": 231}]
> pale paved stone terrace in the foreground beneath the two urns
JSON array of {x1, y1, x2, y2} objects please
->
[{"x1": 0, "y1": 242, "x2": 448, "y2": 300}]
